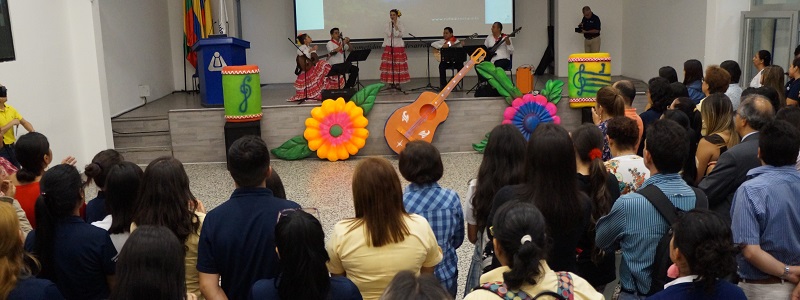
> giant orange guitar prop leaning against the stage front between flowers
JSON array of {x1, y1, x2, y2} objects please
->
[{"x1": 383, "y1": 48, "x2": 486, "y2": 154}]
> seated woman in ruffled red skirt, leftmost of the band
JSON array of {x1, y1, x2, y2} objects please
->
[{"x1": 288, "y1": 33, "x2": 331, "y2": 102}]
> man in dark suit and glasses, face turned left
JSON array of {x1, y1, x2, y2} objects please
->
[{"x1": 697, "y1": 95, "x2": 775, "y2": 221}]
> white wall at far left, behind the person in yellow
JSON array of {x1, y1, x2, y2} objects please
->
[{"x1": 0, "y1": 0, "x2": 113, "y2": 169}]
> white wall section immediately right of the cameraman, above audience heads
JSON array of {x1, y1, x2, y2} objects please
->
[{"x1": 622, "y1": 0, "x2": 708, "y2": 81}]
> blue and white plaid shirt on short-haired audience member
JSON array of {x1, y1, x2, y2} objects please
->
[{"x1": 403, "y1": 183, "x2": 464, "y2": 283}]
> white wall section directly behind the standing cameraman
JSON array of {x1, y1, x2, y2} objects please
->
[{"x1": 556, "y1": 0, "x2": 624, "y2": 77}]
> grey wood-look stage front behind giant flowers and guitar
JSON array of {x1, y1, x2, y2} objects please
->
[{"x1": 112, "y1": 75, "x2": 647, "y2": 164}]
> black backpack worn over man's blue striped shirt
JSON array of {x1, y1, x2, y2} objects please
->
[{"x1": 636, "y1": 185, "x2": 708, "y2": 296}]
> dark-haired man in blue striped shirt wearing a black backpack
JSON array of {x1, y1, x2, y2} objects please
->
[{"x1": 595, "y1": 120, "x2": 696, "y2": 300}]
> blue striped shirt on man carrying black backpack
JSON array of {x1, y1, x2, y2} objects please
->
[{"x1": 595, "y1": 173, "x2": 695, "y2": 294}]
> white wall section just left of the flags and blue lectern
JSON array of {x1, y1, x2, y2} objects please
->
[{"x1": 95, "y1": 0, "x2": 174, "y2": 115}]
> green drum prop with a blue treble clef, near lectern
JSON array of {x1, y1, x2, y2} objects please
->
[{"x1": 222, "y1": 65, "x2": 262, "y2": 122}]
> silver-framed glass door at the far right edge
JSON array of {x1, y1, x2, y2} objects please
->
[{"x1": 740, "y1": 11, "x2": 798, "y2": 87}]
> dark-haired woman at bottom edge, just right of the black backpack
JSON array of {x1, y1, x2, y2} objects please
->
[{"x1": 647, "y1": 209, "x2": 747, "y2": 300}]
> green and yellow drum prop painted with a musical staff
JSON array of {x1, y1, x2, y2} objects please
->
[{"x1": 567, "y1": 53, "x2": 611, "y2": 108}]
